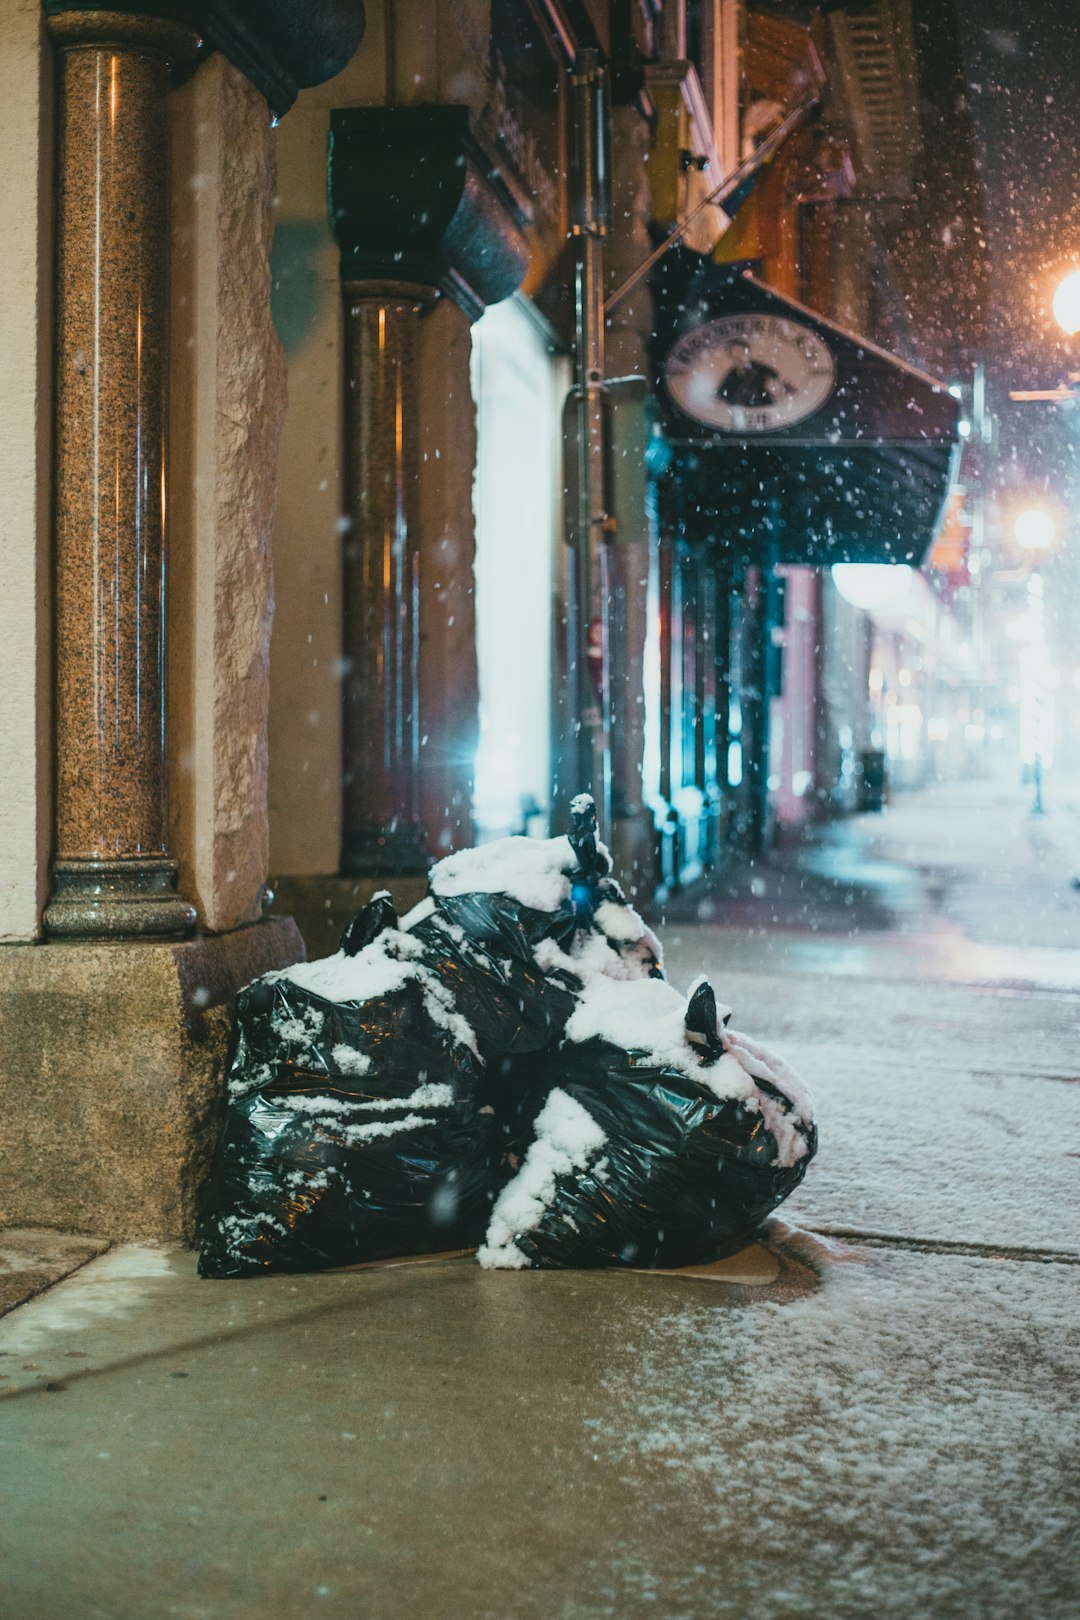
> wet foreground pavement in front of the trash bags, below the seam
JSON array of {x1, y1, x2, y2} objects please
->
[{"x1": 0, "y1": 1224, "x2": 1080, "y2": 1620}]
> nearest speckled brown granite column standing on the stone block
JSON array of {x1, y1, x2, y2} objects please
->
[{"x1": 45, "y1": 11, "x2": 198, "y2": 936}]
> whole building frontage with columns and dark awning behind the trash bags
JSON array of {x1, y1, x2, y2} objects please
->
[{"x1": 0, "y1": 0, "x2": 977, "y2": 1236}]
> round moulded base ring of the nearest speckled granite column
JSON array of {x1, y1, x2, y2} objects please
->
[{"x1": 45, "y1": 859, "x2": 196, "y2": 940}]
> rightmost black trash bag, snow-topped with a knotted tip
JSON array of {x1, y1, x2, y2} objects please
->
[{"x1": 478, "y1": 975, "x2": 818, "y2": 1268}]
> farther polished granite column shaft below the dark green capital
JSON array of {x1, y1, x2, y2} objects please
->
[{"x1": 342, "y1": 282, "x2": 434, "y2": 875}]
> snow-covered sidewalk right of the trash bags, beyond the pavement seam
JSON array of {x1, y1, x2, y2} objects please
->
[{"x1": 662, "y1": 784, "x2": 1080, "y2": 1257}]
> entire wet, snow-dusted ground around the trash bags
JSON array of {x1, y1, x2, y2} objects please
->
[{"x1": 0, "y1": 784, "x2": 1080, "y2": 1620}]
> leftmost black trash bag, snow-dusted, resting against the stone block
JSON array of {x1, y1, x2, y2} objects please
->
[{"x1": 199, "y1": 897, "x2": 502, "y2": 1277}]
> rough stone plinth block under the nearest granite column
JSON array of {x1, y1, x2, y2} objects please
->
[{"x1": 0, "y1": 917, "x2": 304, "y2": 1243}]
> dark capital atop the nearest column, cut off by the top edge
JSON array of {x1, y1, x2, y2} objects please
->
[{"x1": 42, "y1": 0, "x2": 364, "y2": 118}]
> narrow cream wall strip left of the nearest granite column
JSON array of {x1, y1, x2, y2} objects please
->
[{"x1": 0, "y1": 0, "x2": 53, "y2": 941}]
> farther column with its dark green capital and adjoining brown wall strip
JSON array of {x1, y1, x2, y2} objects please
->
[{"x1": 329, "y1": 105, "x2": 528, "y2": 876}]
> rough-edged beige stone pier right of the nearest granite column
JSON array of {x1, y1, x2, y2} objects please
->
[{"x1": 170, "y1": 57, "x2": 285, "y2": 930}]
